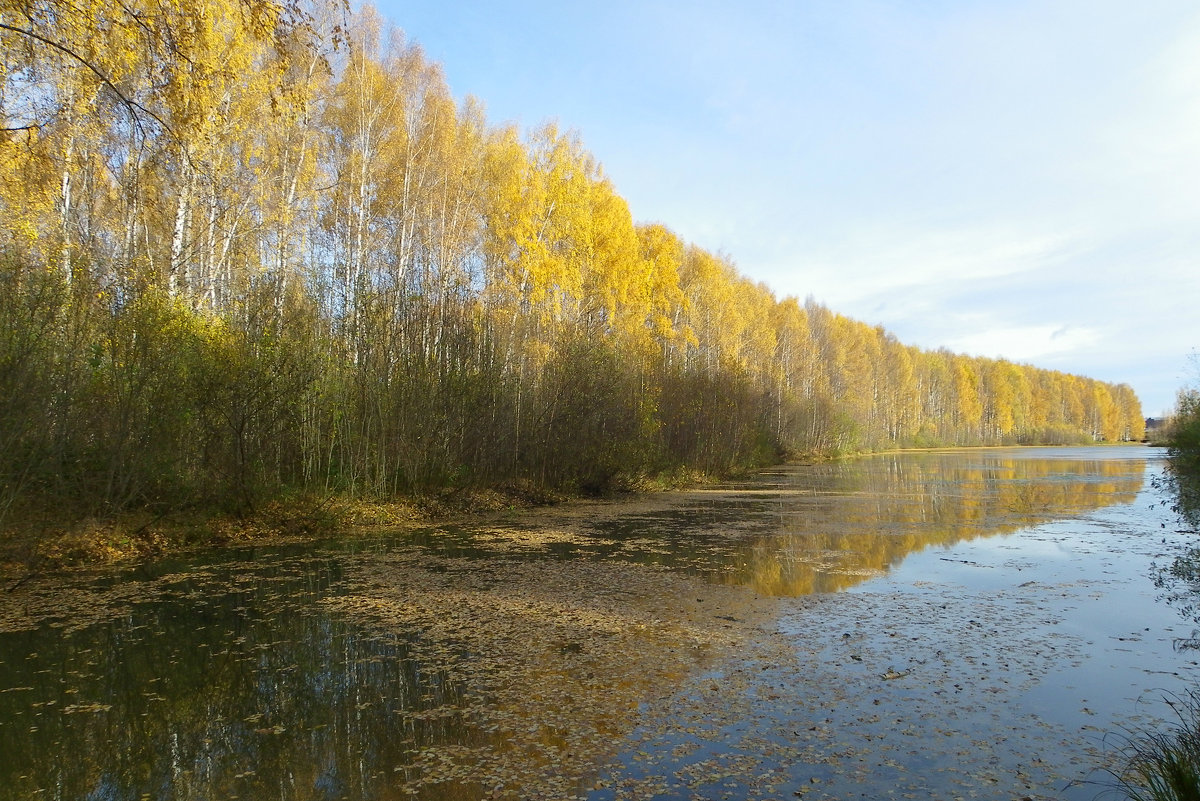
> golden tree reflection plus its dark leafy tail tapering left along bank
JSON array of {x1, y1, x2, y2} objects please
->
[{"x1": 463, "y1": 448, "x2": 1147, "y2": 596}]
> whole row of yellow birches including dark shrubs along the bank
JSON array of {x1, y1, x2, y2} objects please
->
[{"x1": 0, "y1": 0, "x2": 1142, "y2": 513}]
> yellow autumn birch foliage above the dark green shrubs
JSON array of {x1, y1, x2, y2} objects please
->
[{"x1": 0, "y1": 0, "x2": 1142, "y2": 479}]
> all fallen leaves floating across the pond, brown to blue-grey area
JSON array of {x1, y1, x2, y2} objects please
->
[{"x1": 0, "y1": 453, "x2": 1195, "y2": 801}]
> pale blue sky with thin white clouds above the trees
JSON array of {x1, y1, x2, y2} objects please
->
[{"x1": 376, "y1": 0, "x2": 1200, "y2": 416}]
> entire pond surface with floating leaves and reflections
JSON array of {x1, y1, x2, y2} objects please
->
[{"x1": 0, "y1": 447, "x2": 1200, "y2": 801}]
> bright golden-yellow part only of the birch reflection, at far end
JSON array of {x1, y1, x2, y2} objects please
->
[{"x1": 710, "y1": 453, "x2": 1145, "y2": 596}]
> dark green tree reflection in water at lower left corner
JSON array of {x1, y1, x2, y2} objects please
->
[{"x1": 0, "y1": 560, "x2": 479, "y2": 799}]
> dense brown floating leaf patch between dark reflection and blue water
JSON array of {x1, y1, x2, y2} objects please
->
[{"x1": 324, "y1": 555, "x2": 772, "y2": 799}]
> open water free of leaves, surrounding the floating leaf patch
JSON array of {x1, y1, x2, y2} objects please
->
[{"x1": 0, "y1": 447, "x2": 1195, "y2": 800}]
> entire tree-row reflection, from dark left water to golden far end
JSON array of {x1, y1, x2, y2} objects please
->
[{"x1": 0, "y1": 443, "x2": 1145, "y2": 800}]
